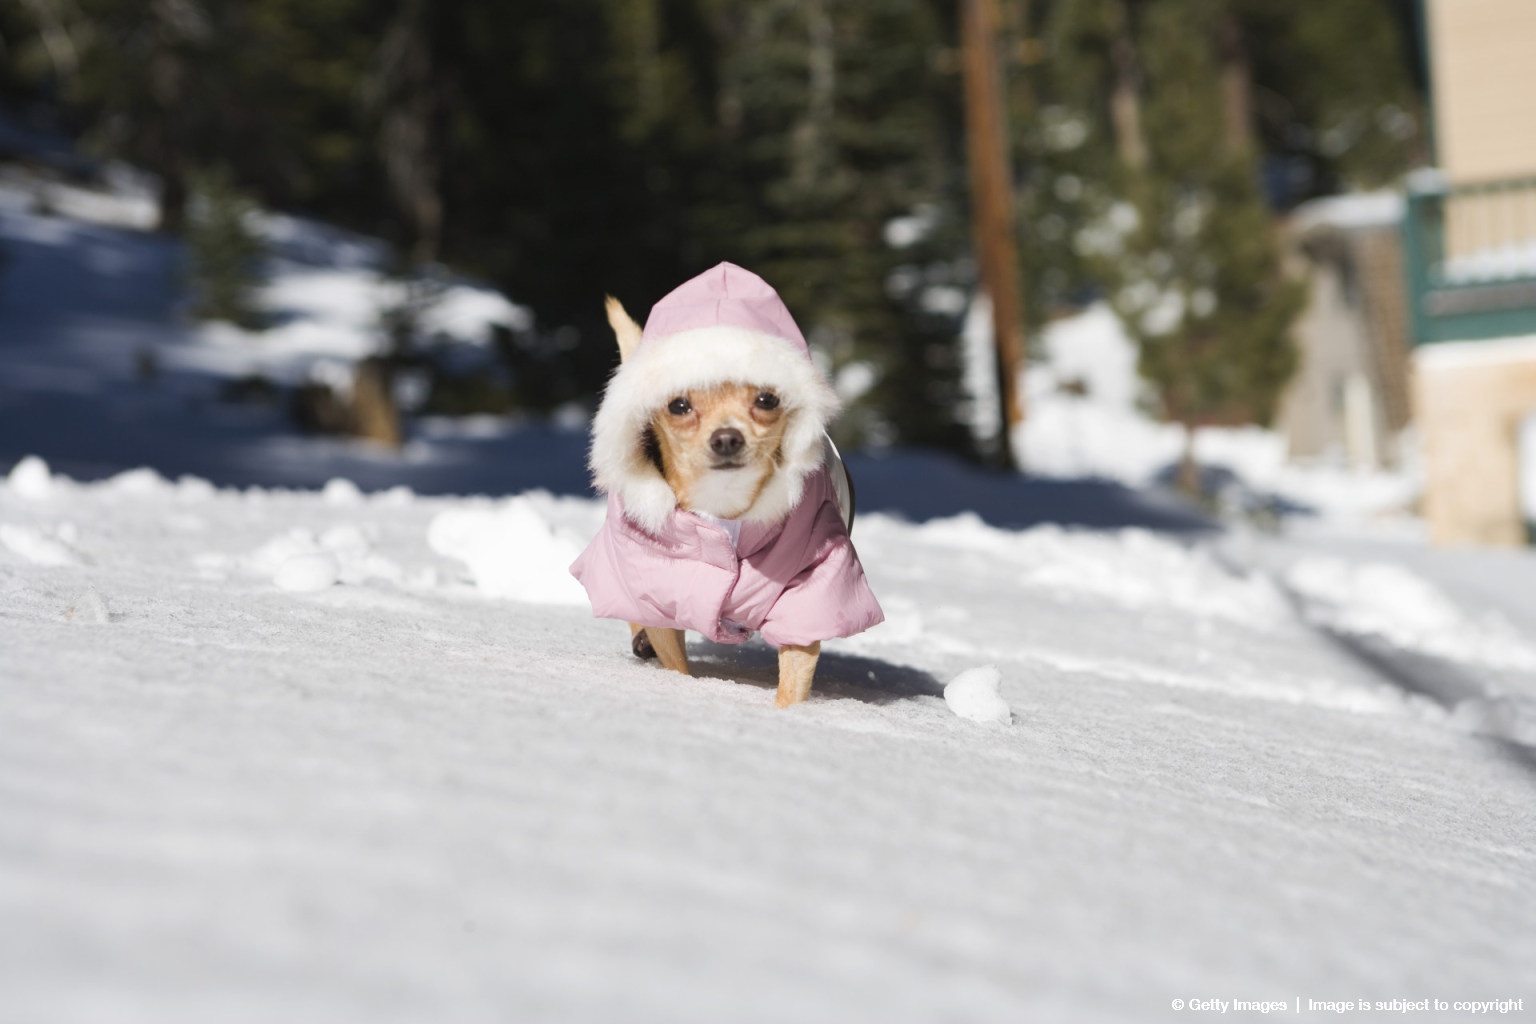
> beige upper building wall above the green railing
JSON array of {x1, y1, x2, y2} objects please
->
[{"x1": 1425, "y1": 0, "x2": 1536, "y2": 184}]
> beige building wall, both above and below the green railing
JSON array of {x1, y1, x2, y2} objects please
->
[{"x1": 1413, "y1": 0, "x2": 1536, "y2": 545}]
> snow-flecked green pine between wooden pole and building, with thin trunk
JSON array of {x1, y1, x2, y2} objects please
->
[{"x1": 1106, "y1": 0, "x2": 1304, "y2": 491}]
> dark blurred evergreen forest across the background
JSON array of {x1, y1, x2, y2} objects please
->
[{"x1": 0, "y1": 0, "x2": 1427, "y2": 454}]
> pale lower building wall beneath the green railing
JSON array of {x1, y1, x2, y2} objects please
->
[{"x1": 1415, "y1": 338, "x2": 1536, "y2": 545}]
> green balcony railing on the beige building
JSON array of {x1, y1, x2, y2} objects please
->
[{"x1": 1402, "y1": 177, "x2": 1536, "y2": 344}]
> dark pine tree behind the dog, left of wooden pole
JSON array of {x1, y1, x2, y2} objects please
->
[{"x1": 703, "y1": 0, "x2": 971, "y2": 451}]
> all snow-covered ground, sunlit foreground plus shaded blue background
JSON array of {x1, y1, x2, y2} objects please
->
[{"x1": 0, "y1": 166, "x2": 1536, "y2": 1024}]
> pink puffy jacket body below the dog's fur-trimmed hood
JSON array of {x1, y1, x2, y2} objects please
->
[{"x1": 571, "y1": 465, "x2": 885, "y2": 646}]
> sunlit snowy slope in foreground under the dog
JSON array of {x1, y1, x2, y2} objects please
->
[{"x1": 0, "y1": 462, "x2": 1536, "y2": 1024}]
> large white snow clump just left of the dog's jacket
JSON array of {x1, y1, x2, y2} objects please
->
[{"x1": 427, "y1": 496, "x2": 587, "y2": 605}]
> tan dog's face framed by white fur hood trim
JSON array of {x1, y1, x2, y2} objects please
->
[{"x1": 651, "y1": 384, "x2": 788, "y2": 519}]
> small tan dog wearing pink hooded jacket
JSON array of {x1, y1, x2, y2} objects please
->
[{"x1": 571, "y1": 264, "x2": 883, "y2": 708}]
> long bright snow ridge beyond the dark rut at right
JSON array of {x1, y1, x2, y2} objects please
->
[{"x1": 1286, "y1": 557, "x2": 1536, "y2": 671}]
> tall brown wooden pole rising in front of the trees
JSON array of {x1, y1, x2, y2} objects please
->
[{"x1": 960, "y1": 0, "x2": 1025, "y2": 468}]
